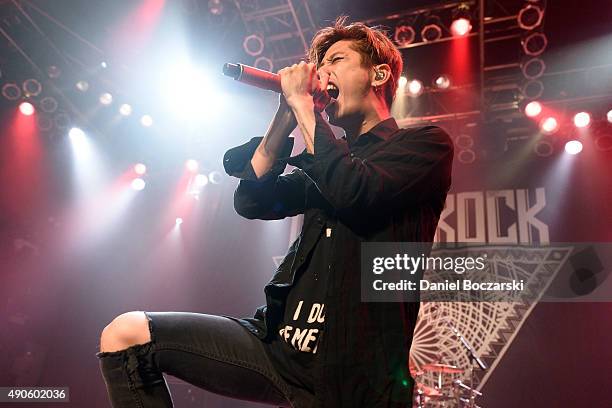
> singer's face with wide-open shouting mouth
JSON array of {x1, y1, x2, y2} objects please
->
[{"x1": 319, "y1": 40, "x2": 372, "y2": 126}]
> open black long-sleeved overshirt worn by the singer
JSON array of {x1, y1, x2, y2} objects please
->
[{"x1": 224, "y1": 115, "x2": 453, "y2": 408}]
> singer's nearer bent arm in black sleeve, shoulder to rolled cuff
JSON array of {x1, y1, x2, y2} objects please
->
[{"x1": 289, "y1": 113, "x2": 453, "y2": 212}]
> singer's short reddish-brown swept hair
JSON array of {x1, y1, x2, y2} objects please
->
[{"x1": 308, "y1": 16, "x2": 403, "y2": 109}]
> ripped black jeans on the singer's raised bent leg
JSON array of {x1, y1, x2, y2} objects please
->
[{"x1": 96, "y1": 312, "x2": 310, "y2": 408}]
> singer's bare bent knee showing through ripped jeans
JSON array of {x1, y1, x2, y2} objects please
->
[{"x1": 100, "y1": 312, "x2": 151, "y2": 352}]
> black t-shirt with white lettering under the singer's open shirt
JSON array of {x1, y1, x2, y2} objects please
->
[{"x1": 268, "y1": 225, "x2": 333, "y2": 392}]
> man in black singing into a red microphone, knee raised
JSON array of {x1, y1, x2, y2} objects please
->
[{"x1": 97, "y1": 18, "x2": 453, "y2": 408}]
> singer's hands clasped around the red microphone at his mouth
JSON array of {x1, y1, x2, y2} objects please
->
[{"x1": 278, "y1": 61, "x2": 331, "y2": 112}]
